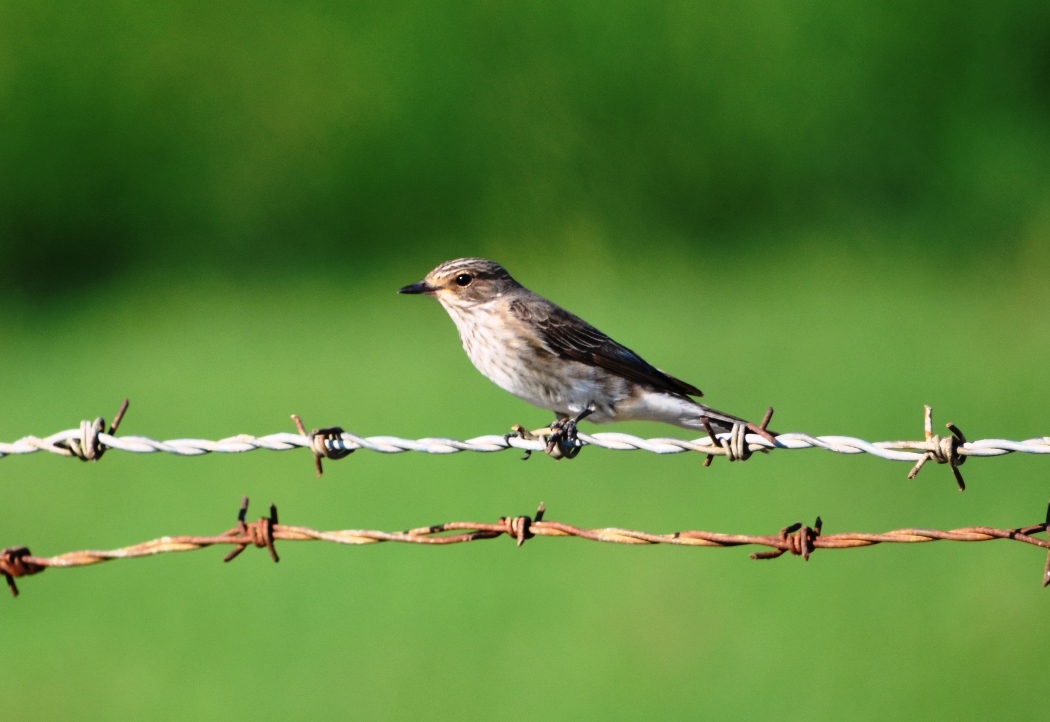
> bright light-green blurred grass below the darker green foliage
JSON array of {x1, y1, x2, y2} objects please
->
[{"x1": 0, "y1": 247, "x2": 1050, "y2": 719}]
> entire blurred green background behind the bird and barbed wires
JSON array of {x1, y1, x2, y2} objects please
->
[{"x1": 0, "y1": 0, "x2": 1050, "y2": 720}]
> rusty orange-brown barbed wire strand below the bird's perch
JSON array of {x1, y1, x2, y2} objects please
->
[{"x1": 6, "y1": 496, "x2": 1050, "y2": 596}]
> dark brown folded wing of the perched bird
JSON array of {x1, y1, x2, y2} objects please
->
[{"x1": 510, "y1": 297, "x2": 704, "y2": 397}]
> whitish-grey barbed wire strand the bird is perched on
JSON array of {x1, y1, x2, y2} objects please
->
[{"x1": 0, "y1": 400, "x2": 1050, "y2": 489}]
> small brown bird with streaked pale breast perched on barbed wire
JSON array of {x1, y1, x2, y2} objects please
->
[{"x1": 398, "y1": 258, "x2": 773, "y2": 455}]
